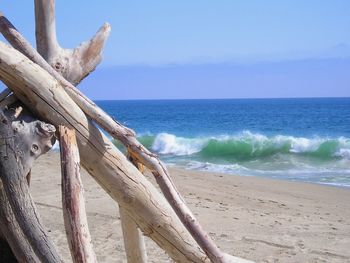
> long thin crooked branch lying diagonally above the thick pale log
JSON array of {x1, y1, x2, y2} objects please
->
[{"x1": 0, "y1": 13, "x2": 252, "y2": 262}]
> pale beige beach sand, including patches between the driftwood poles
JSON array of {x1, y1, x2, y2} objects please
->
[{"x1": 31, "y1": 152, "x2": 350, "y2": 262}]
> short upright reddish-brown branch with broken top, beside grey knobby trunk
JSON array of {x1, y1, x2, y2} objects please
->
[{"x1": 59, "y1": 126, "x2": 97, "y2": 263}]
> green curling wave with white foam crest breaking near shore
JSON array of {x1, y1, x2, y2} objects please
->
[{"x1": 139, "y1": 131, "x2": 350, "y2": 161}]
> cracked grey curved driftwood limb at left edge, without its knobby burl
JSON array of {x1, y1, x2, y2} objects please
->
[{"x1": 0, "y1": 111, "x2": 62, "y2": 263}]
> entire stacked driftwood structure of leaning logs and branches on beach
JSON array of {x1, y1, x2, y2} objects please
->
[{"x1": 0, "y1": 0, "x2": 252, "y2": 263}]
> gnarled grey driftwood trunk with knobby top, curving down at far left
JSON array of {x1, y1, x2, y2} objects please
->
[{"x1": 0, "y1": 108, "x2": 62, "y2": 262}]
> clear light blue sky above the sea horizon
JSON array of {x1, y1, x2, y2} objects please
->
[{"x1": 1, "y1": 0, "x2": 350, "y2": 99}]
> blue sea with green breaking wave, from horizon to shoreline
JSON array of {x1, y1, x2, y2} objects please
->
[{"x1": 96, "y1": 98, "x2": 350, "y2": 187}]
